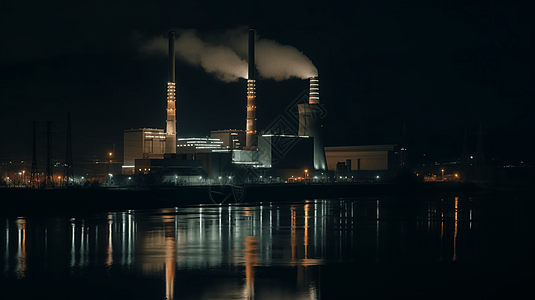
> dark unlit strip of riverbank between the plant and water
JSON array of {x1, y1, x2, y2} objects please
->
[{"x1": 0, "y1": 182, "x2": 533, "y2": 215}]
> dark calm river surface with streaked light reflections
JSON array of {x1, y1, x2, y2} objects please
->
[{"x1": 0, "y1": 196, "x2": 533, "y2": 299}]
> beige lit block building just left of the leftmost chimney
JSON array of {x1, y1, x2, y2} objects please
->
[{"x1": 122, "y1": 128, "x2": 166, "y2": 174}]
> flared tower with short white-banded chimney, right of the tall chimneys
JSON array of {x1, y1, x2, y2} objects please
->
[{"x1": 297, "y1": 77, "x2": 327, "y2": 170}]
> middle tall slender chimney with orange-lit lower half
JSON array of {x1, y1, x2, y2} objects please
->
[{"x1": 245, "y1": 29, "x2": 258, "y2": 149}]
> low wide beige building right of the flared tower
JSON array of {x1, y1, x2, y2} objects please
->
[{"x1": 325, "y1": 145, "x2": 400, "y2": 182}]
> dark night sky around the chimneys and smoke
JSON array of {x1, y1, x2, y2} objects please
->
[{"x1": 0, "y1": 1, "x2": 535, "y2": 166}]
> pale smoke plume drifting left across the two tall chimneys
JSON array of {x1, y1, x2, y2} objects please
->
[{"x1": 141, "y1": 26, "x2": 318, "y2": 82}]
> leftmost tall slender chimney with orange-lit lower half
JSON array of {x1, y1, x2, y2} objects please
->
[{"x1": 165, "y1": 31, "x2": 176, "y2": 153}]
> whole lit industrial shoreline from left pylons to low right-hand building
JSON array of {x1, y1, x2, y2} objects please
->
[{"x1": 0, "y1": 29, "x2": 403, "y2": 187}]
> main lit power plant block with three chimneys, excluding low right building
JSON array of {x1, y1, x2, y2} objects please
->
[{"x1": 122, "y1": 29, "x2": 393, "y2": 185}]
